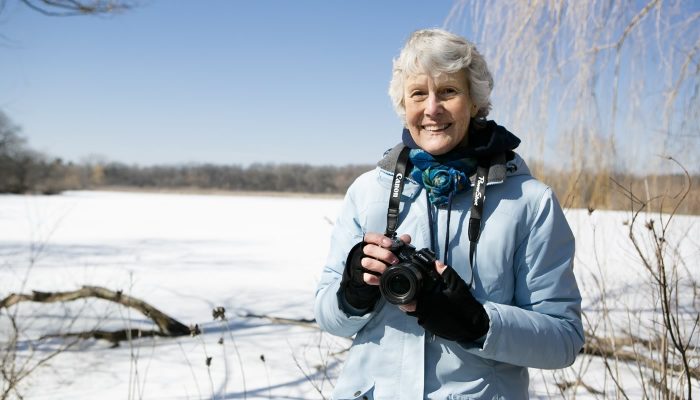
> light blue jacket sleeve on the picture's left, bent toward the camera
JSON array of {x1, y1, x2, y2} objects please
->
[{"x1": 314, "y1": 186, "x2": 374, "y2": 337}]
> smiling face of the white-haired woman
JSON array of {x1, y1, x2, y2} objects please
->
[{"x1": 404, "y1": 70, "x2": 477, "y2": 155}]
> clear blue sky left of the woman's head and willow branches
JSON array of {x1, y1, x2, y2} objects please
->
[{"x1": 0, "y1": 0, "x2": 460, "y2": 165}]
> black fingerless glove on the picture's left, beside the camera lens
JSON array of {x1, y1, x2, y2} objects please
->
[{"x1": 340, "y1": 242, "x2": 380, "y2": 311}]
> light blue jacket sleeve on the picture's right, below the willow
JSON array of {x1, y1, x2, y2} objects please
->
[{"x1": 469, "y1": 188, "x2": 584, "y2": 369}]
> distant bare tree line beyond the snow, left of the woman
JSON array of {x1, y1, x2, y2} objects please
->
[{"x1": 0, "y1": 111, "x2": 373, "y2": 194}]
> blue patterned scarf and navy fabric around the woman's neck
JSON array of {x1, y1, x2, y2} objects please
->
[{"x1": 403, "y1": 120, "x2": 520, "y2": 206}]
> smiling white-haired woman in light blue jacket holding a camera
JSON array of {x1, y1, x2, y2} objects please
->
[{"x1": 315, "y1": 29, "x2": 583, "y2": 400}]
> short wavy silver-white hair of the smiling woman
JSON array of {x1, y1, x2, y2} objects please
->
[{"x1": 389, "y1": 29, "x2": 493, "y2": 120}]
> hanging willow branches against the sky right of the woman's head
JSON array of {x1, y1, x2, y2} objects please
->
[{"x1": 446, "y1": 0, "x2": 700, "y2": 209}]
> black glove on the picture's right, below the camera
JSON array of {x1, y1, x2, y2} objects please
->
[{"x1": 408, "y1": 265, "x2": 489, "y2": 342}]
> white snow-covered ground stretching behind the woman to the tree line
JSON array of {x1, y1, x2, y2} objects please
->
[{"x1": 0, "y1": 191, "x2": 700, "y2": 399}]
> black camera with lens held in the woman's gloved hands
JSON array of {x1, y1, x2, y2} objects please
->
[{"x1": 379, "y1": 239, "x2": 440, "y2": 304}]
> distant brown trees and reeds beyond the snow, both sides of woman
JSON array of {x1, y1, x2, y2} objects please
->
[{"x1": 0, "y1": 111, "x2": 700, "y2": 214}]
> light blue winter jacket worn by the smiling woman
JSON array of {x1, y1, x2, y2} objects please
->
[{"x1": 314, "y1": 148, "x2": 584, "y2": 400}]
